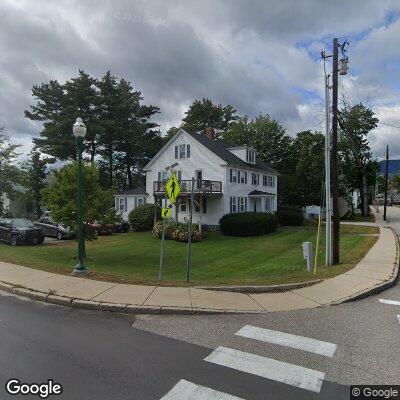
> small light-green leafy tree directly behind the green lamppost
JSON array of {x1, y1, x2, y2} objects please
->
[{"x1": 42, "y1": 162, "x2": 116, "y2": 230}]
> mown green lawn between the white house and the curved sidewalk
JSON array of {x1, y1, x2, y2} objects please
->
[{"x1": 0, "y1": 225, "x2": 378, "y2": 285}]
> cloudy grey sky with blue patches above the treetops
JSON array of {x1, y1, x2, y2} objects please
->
[{"x1": 0, "y1": 0, "x2": 400, "y2": 158}]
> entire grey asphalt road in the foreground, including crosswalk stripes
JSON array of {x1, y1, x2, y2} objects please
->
[{"x1": 0, "y1": 210, "x2": 400, "y2": 400}]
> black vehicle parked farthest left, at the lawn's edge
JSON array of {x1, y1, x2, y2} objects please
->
[{"x1": 0, "y1": 218, "x2": 44, "y2": 246}]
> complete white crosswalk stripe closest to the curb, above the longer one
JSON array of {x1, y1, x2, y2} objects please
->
[{"x1": 235, "y1": 325, "x2": 337, "y2": 357}]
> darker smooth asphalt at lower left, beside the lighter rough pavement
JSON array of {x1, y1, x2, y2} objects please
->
[{"x1": 0, "y1": 293, "x2": 348, "y2": 400}]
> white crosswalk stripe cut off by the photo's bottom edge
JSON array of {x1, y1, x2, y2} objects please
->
[{"x1": 160, "y1": 379, "x2": 244, "y2": 400}]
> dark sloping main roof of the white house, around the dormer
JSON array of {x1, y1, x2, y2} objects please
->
[{"x1": 188, "y1": 133, "x2": 278, "y2": 174}]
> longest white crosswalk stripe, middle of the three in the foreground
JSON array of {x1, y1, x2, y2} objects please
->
[{"x1": 204, "y1": 347, "x2": 325, "y2": 393}]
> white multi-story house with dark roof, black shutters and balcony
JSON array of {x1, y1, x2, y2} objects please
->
[{"x1": 144, "y1": 128, "x2": 278, "y2": 228}]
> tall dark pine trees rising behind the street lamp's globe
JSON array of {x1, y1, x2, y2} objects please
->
[{"x1": 25, "y1": 71, "x2": 162, "y2": 188}]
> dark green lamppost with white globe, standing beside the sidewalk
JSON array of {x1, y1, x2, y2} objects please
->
[{"x1": 72, "y1": 118, "x2": 88, "y2": 275}]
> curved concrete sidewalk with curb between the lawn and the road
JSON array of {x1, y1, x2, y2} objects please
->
[{"x1": 0, "y1": 227, "x2": 398, "y2": 314}]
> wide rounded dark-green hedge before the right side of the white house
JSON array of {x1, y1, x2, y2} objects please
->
[{"x1": 219, "y1": 212, "x2": 278, "y2": 236}]
